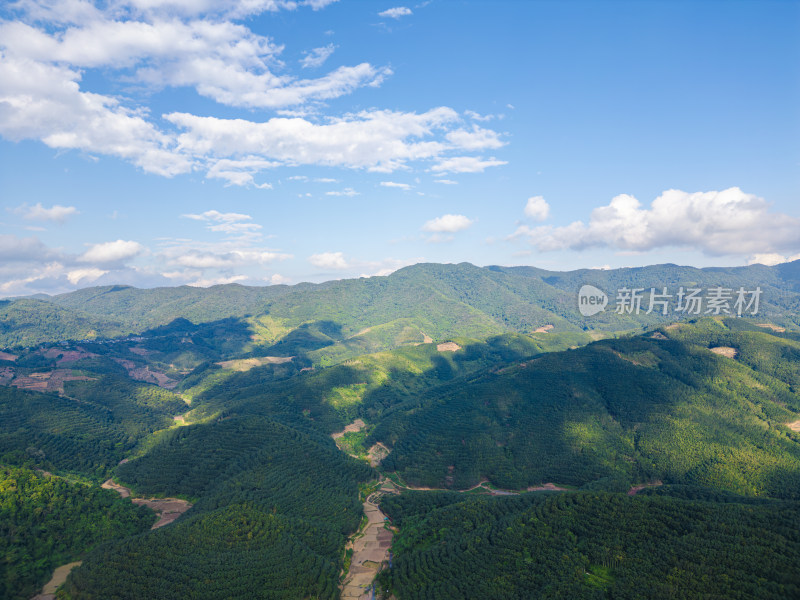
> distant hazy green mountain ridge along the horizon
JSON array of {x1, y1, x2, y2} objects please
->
[{"x1": 0, "y1": 261, "x2": 800, "y2": 352}]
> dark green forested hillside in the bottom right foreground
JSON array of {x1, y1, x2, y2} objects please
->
[{"x1": 381, "y1": 489, "x2": 800, "y2": 600}]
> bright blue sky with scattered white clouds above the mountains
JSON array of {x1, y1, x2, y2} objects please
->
[{"x1": 0, "y1": 0, "x2": 800, "y2": 296}]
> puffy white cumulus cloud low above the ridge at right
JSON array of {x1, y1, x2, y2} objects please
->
[{"x1": 510, "y1": 187, "x2": 800, "y2": 256}]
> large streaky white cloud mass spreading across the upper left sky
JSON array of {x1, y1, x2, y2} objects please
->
[{"x1": 0, "y1": 0, "x2": 505, "y2": 189}]
